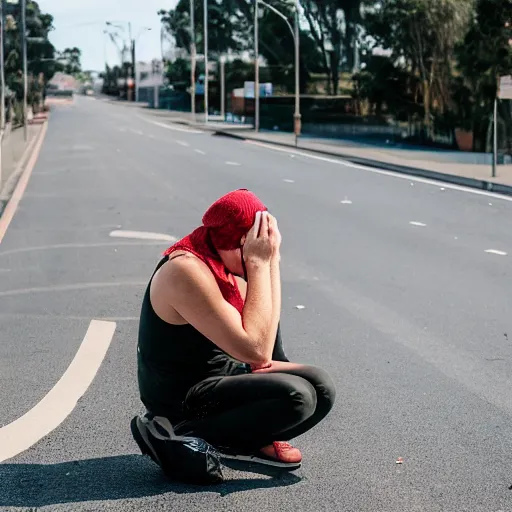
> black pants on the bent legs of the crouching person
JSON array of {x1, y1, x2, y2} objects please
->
[{"x1": 175, "y1": 366, "x2": 335, "y2": 453}]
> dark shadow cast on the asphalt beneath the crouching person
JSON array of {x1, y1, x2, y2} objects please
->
[{"x1": 0, "y1": 455, "x2": 301, "y2": 510}]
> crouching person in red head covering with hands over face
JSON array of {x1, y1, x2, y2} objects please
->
[{"x1": 131, "y1": 189, "x2": 335, "y2": 469}]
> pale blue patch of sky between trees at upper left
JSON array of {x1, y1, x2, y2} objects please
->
[{"x1": 38, "y1": 0, "x2": 177, "y2": 71}]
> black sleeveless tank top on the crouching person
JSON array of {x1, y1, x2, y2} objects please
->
[{"x1": 137, "y1": 256, "x2": 250, "y2": 424}]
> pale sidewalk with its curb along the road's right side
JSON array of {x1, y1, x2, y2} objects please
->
[{"x1": 107, "y1": 99, "x2": 512, "y2": 195}]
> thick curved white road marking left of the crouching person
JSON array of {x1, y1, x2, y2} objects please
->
[{"x1": 0, "y1": 320, "x2": 116, "y2": 462}]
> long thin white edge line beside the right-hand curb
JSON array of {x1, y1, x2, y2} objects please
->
[{"x1": 245, "y1": 140, "x2": 512, "y2": 202}]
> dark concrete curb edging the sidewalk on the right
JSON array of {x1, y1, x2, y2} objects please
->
[{"x1": 214, "y1": 130, "x2": 512, "y2": 196}]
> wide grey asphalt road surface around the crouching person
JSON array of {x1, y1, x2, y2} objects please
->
[{"x1": 0, "y1": 98, "x2": 512, "y2": 512}]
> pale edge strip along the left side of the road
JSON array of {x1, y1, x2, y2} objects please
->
[{"x1": 0, "y1": 116, "x2": 49, "y2": 244}]
